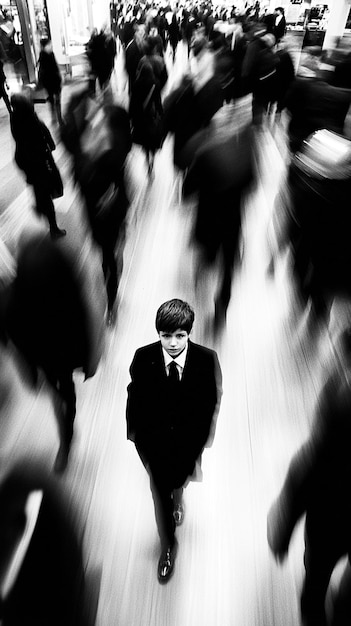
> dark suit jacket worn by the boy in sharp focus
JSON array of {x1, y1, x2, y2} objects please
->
[{"x1": 127, "y1": 341, "x2": 221, "y2": 477}]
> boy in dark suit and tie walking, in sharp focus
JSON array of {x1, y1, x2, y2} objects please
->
[{"x1": 127, "y1": 299, "x2": 221, "y2": 583}]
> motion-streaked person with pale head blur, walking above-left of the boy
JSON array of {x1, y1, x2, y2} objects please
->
[{"x1": 62, "y1": 88, "x2": 132, "y2": 326}]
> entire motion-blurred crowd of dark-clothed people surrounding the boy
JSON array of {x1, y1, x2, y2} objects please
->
[{"x1": 0, "y1": 3, "x2": 351, "y2": 626}]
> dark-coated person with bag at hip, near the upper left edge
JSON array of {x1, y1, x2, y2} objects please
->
[{"x1": 11, "y1": 93, "x2": 66, "y2": 238}]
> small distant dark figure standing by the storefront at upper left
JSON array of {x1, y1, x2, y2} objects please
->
[{"x1": 38, "y1": 37, "x2": 62, "y2": 124}]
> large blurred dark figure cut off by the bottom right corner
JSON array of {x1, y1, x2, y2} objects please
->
[{"x1": 267, "y1": 320, "x2": 351, "y2": 626}]
